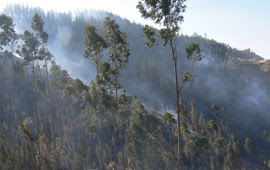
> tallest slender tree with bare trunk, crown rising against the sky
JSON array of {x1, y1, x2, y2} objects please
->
[{"x1": 137, "y1": 0, "x2": 200, "y2": 169}]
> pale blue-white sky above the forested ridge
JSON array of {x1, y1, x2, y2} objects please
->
[{"x1": 0, "y1": 0, "x2": 270, "y2": 59}]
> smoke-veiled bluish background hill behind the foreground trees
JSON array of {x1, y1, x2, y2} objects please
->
[{"x1": 4, "y1": 5, "x2": 270, "y2": 153}]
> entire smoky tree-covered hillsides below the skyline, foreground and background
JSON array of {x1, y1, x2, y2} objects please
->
[{"x1": 0, "y1": 1, "x2": 270, "y2": 170}]
